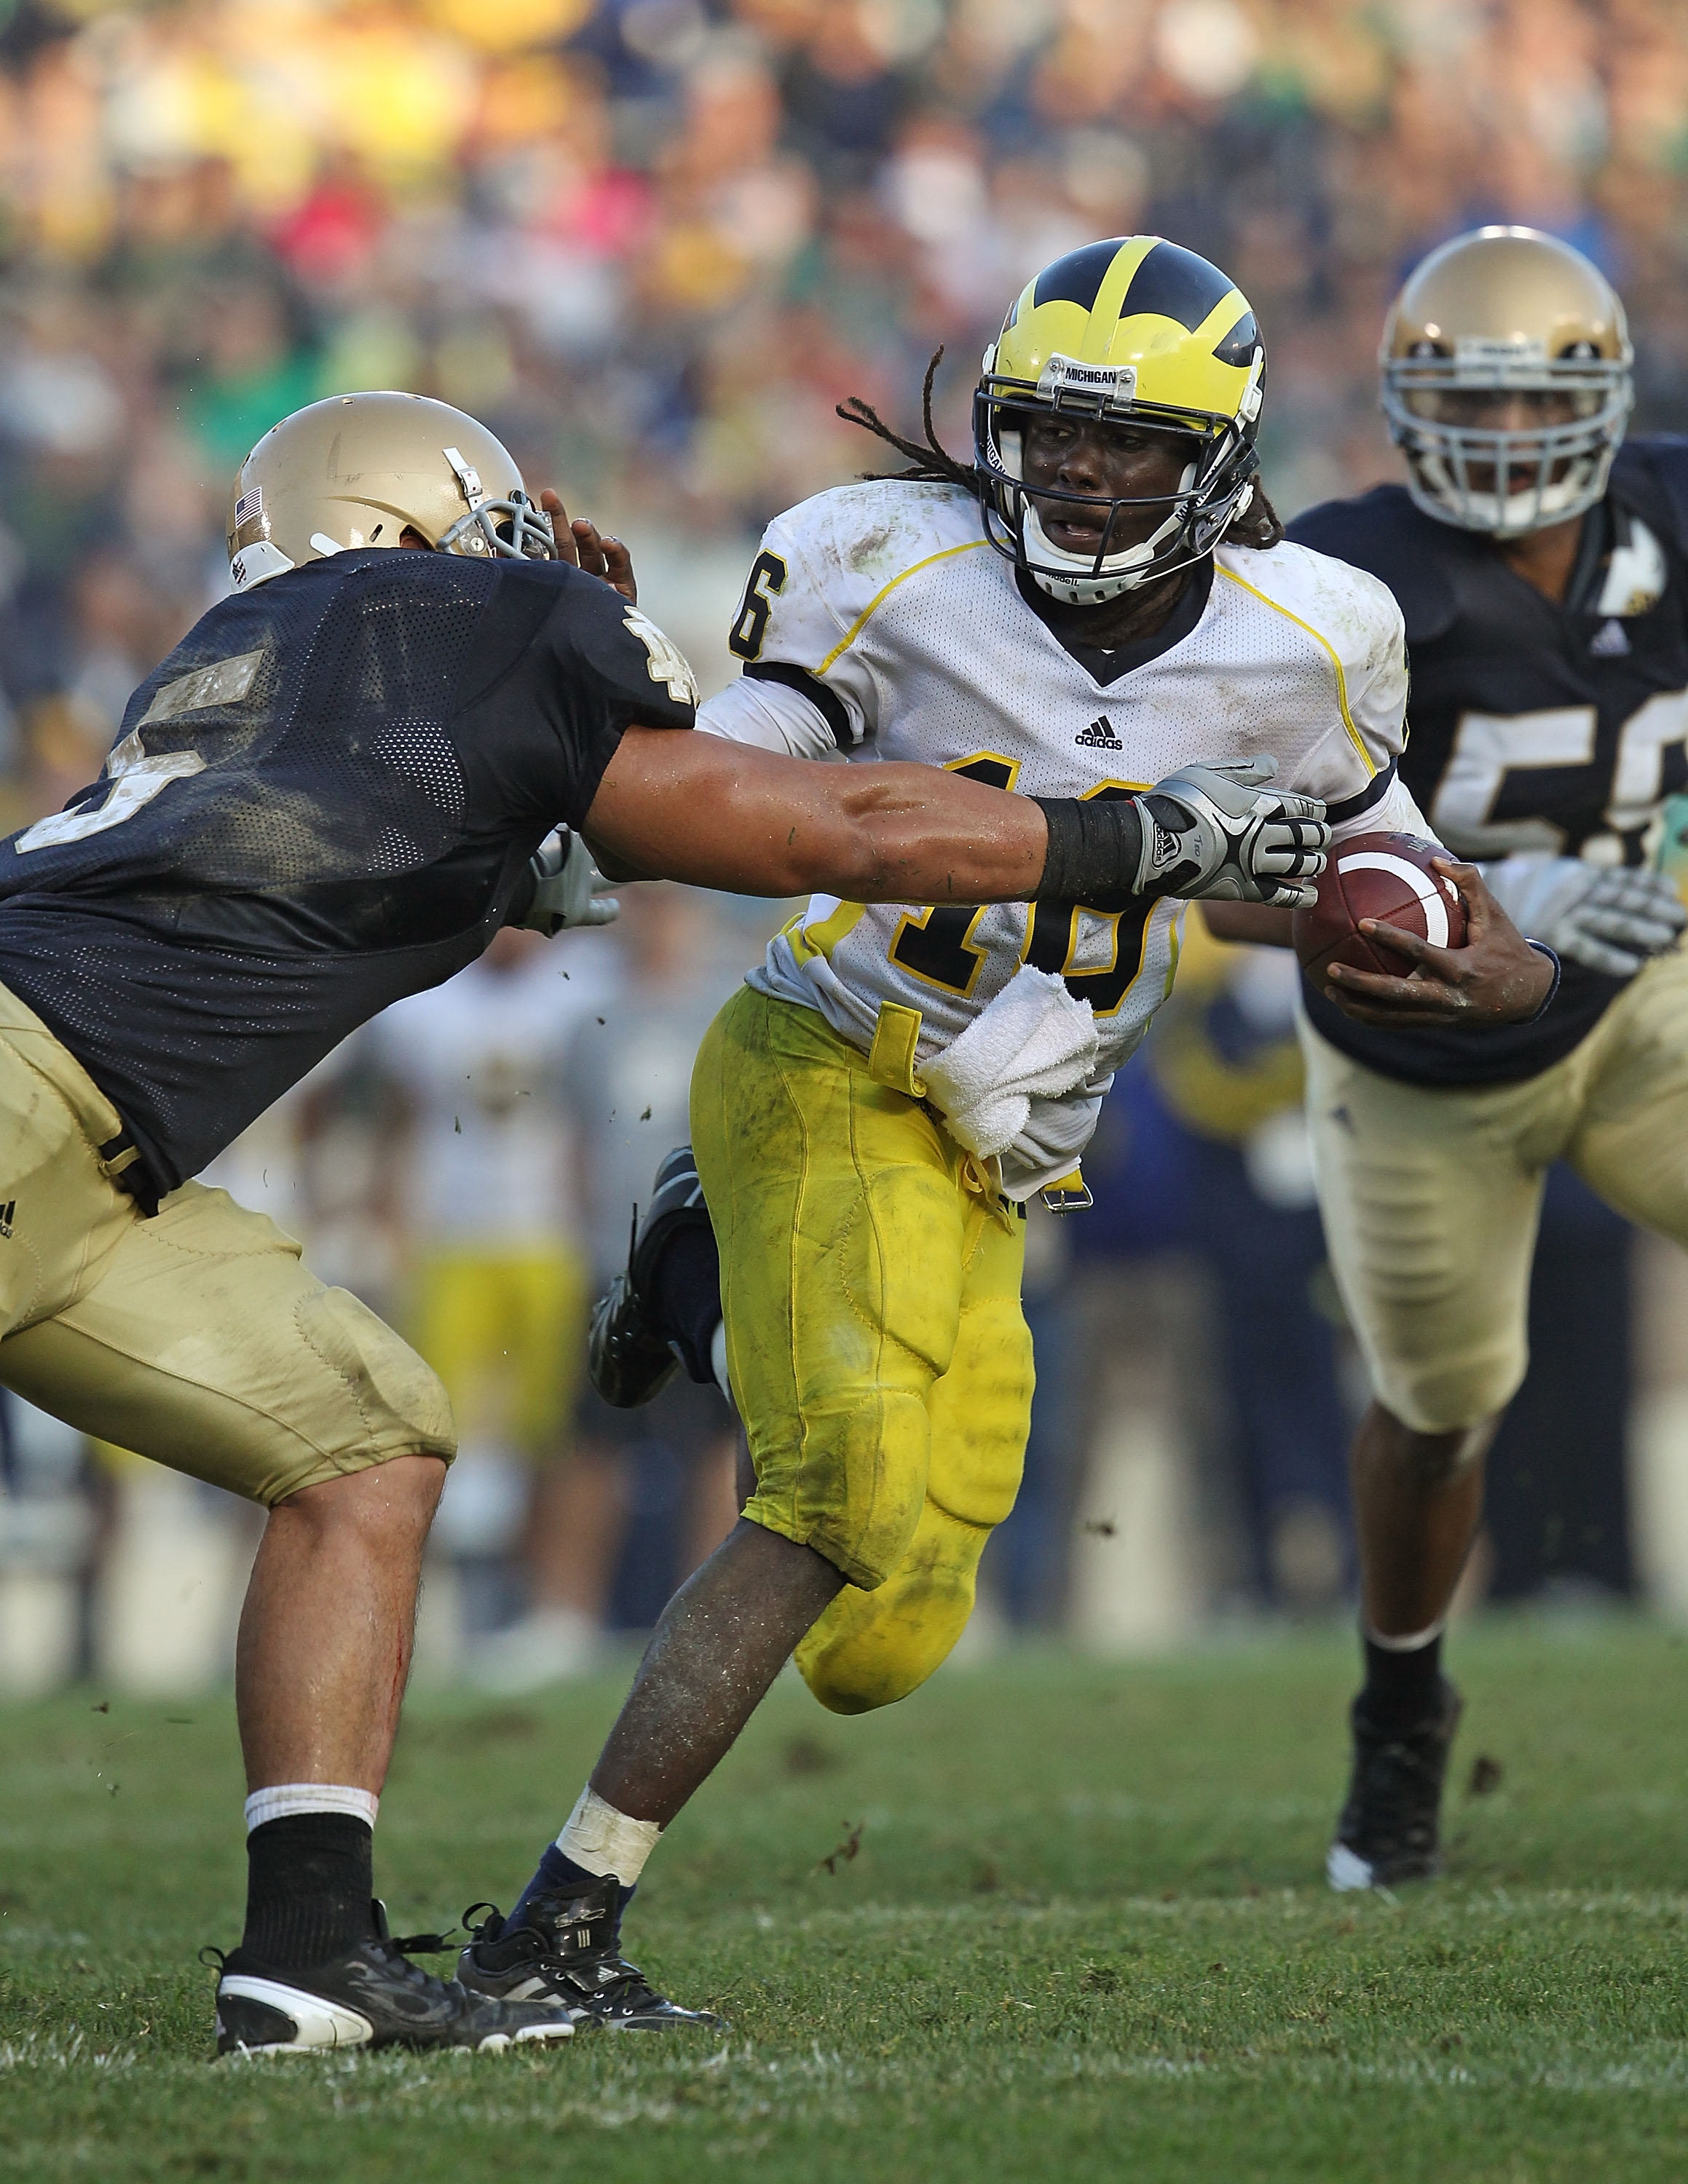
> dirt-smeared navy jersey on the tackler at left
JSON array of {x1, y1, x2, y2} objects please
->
[{"x1": 0, "y1": 550, "x2": 695, "y2": 1190}]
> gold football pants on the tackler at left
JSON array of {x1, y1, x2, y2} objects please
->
[{"x1": 0, "y1": 987, "x2": 457, "y2": 1505}]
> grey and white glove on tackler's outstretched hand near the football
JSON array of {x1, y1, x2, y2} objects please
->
[{"x1": 1137, "y1": 753, "x2": 1330, "y2": 909}]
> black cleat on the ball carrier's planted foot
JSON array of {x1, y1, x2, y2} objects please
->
[{"x1": 457, "y1": 1874, "x2": 727, "y2": 2033}]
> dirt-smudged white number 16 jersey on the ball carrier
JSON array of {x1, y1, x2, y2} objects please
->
[{"x1": 697, "y1": 478, "x2": 1424, "y2": 1188}]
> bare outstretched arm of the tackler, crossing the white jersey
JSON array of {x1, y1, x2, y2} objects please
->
[{"x1": 585, "y1": 727, "x2": 1048, "y2": 902}]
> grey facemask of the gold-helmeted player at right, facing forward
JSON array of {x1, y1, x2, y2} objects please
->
[{"x1": 1382, "y1": 356, "x2": 1636, "y2": 537}]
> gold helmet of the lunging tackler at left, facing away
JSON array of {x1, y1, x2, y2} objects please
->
[{"x1": 229, "y1": 393, "x2": 557, "y2": 592}]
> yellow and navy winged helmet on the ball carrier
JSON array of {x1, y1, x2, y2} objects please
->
[{"x1": 974, "y1": 236, "x2": 1266, "y2": 605}]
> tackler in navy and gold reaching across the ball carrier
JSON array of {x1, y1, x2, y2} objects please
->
[{"x1": 0, "y1": 393, "x2": 1118, "y2": 2051}]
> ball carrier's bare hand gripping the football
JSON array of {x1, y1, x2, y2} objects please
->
[{"x1": 1325, "y1": 856, "x2": 1559, "y2": 1031}]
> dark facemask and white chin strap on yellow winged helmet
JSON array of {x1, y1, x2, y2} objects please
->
[{"x1": 974, "y1": 373, "x2": 1260, "y2": 605}]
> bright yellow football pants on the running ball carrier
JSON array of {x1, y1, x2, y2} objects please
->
[{"x1": 693, "y1": 987, "x2": 1033, "y2": 1714}]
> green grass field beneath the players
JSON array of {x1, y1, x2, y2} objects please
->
[{"x1": 0, "y1": 1623, "x2": 1688, "y2": 2184}]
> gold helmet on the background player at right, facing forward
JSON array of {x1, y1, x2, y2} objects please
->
[{"x1": 1378, "y1": 227, "x2": 1633, "y2": 537}]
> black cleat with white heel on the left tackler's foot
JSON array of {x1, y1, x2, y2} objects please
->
[{"x1": 216, "y1": 1902, "x2": 575, "y2": 2055}]
